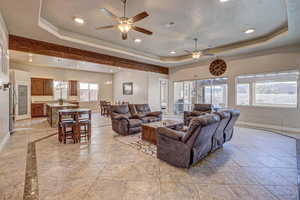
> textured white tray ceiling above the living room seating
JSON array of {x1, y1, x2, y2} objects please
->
[{"x1": 0, "y1": 0, "x2": 300, "y2": 67}]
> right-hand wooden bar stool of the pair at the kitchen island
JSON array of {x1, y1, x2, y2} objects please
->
[{"x1": 77, "y1": 109, "x2": 92, "y2": 142}]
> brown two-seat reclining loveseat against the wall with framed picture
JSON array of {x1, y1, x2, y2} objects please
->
[{"x1": 111, "y1": 104, "x2": 162, "y2": 135}]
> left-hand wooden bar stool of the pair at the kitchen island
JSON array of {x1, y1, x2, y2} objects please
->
[{"x1": 58, "y1": 110, "x2": 77, "y2": 144}]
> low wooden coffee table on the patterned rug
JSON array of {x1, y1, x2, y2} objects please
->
[{"x1": 142, "y1": 120, "x2": 184, "y2": 145}]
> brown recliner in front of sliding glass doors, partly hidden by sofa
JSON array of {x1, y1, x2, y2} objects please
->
[{"x1": 183, "y1": 104, "x2": 213, "y2": 126}]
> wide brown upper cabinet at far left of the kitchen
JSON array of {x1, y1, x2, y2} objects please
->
[{"x1": 31, "y1": 78, "x2": 53, "y2": 96}]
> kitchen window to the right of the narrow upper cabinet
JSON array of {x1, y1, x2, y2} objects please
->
[{"x1": 79, "y1": 83, "x2": 98, "y2": 102}]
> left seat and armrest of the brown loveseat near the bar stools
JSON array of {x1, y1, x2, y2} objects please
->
[{"x1": 111, "y1": 105, "x2": 142, "y2": 135}]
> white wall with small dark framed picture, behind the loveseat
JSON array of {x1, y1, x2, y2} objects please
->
[{"x1": 113, "y1": 70, "x2": 168, "y2": 110}]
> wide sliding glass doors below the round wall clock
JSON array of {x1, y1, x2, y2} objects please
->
[{"x1": 174, "y1": 78, "x2": 228, "y2": 113}]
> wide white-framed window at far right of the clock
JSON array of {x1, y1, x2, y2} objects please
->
[{"x1": 236, "y1": 71, "x2": 299, "y2": 107}]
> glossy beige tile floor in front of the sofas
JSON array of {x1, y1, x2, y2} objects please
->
[{"x1": 0, "y1": 114, "x2": 298, "y2": 200}]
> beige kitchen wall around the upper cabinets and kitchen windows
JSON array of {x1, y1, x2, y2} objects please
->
[{"x1": 10, "y1": 62, "x2": 113, "y2": 107}]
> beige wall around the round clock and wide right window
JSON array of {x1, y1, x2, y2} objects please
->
[{"x1": 169, "y1": 48, "x2": 300, "y2": 132}]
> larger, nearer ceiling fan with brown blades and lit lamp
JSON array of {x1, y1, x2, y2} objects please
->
[{"x1": 96, "y1": 0, "x2": 152, "y2": 40}]
